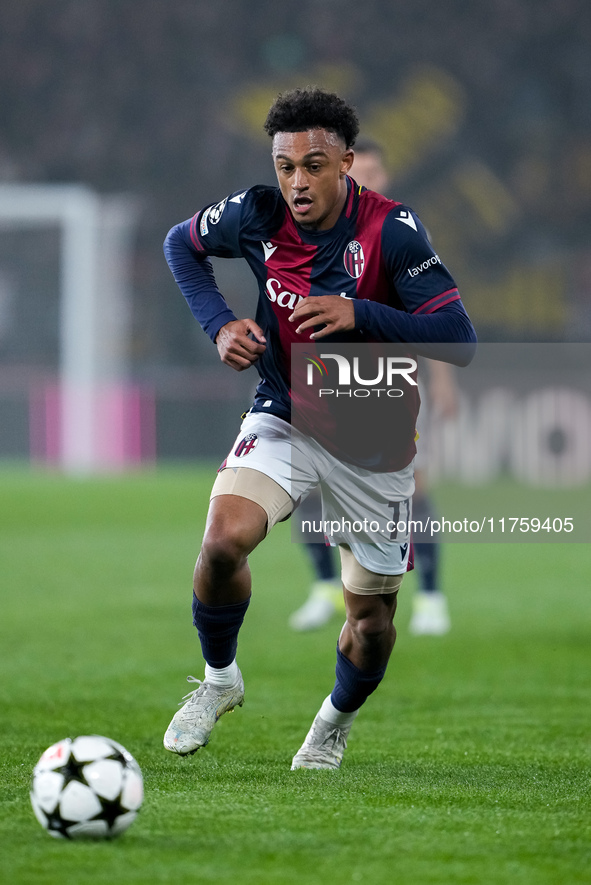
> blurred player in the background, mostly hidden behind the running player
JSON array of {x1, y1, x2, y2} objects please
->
[{"x1": 289, "y1": 139, "x2": 458, "y2": 636}]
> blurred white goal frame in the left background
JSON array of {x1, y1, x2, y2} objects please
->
[{"x1": 0, "y1": 184, "x2": 145, "y2": 474}]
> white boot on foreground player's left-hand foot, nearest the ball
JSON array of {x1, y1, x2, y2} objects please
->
[{"x1": 164, "y1": 670, "x2": 244, "y2": 756}]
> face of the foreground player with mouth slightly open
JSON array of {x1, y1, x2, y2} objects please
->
[{"x1": 273, "y1": 129, "x2": 353, "y2": 230}]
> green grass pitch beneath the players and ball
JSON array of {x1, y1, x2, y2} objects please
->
[{"x1": 0, "y1": 468, "x2": 591, "y2": 885}]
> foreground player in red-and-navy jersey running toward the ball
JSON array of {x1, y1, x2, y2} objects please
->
[{"x1": 164, "y1": 88, "x2": 476, "y2": 769}]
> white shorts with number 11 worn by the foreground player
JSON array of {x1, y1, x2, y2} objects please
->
[{"x1": 224, "y1": 412, "x2": 414, "y2": 575}]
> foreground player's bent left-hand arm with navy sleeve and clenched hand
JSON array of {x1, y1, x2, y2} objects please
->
[{"x1": 164, "y1": 193, "x2": 265, "y2": 371}]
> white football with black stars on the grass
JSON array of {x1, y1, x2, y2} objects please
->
[{"x1": 31, "y1": 735, "x2": 144, "y2": 839}]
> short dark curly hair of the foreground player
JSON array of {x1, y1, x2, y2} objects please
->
[{"x1": 264, "y1": 86, "x2": 359, "y2": 148}]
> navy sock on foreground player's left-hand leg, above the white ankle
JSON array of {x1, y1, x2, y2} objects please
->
[{"x1": 193, "y1": 594, "x2": 250, "y2": 670}]
